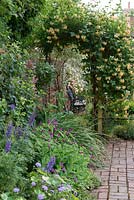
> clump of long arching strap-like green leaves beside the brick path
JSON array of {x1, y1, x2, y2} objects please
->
[{"x1": 52, "y1": 113, "x2": 104, "y2": 167}]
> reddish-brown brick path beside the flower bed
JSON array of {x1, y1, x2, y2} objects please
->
[{"x1": 94, "y1": 141, "x2": 134, "y2": 200}]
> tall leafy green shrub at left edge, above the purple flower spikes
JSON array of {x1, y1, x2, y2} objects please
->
[{"x1": 0, "y1": 43, "x2": 35, "y2": 129}]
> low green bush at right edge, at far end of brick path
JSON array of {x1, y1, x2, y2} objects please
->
[{"x1": 112, "y1": 121, "x2": 134, "y2": 140}]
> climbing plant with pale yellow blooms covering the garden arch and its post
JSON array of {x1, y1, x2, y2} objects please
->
[{"x1": 32, "y1": 0, "x2": 134, "y2": 132}]
